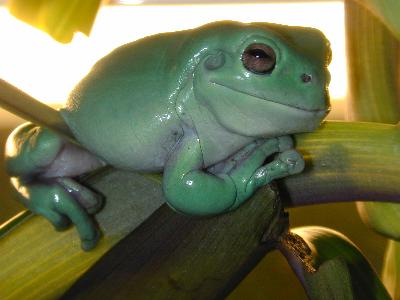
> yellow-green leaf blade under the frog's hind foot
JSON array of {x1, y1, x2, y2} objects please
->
[{"x1": 0, "y1": 170, "x2": 163, "y2": 300}]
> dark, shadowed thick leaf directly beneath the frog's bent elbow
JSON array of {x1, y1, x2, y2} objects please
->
[{"x1": 62, "y1": 182, "x2": 282, "y2": 300}]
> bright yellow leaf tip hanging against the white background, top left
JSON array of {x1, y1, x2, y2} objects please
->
[{"x1": 7, "y1": 0, "x2": 101, "y2": 43}]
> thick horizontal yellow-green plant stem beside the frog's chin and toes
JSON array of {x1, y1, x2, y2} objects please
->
[{"x1": 280, "y1": 122, "x2": 400, "y2": 206}]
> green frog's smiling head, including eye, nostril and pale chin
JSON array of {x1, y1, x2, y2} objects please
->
[{"x1": 193, "y1": 22, "x2": 331, "y2": 137}]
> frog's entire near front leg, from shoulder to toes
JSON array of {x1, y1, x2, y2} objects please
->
[{"x1": 163, "y1": 133, "x2": 304, "y2": 215}]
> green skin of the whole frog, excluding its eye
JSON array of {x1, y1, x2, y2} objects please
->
[{"x1": 6, "y1": 22, "x2": 330, "y2": 250}]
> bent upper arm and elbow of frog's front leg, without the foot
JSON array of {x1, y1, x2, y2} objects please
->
[{"x1": 163, "y1": 132, "x2": 236, "y2": 215}]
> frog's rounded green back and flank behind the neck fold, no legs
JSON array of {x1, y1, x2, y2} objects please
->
[{"x1": 61, "y1": 33, "x2": 188, "y2": 171}]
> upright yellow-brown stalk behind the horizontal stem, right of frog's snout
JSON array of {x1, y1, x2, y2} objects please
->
[{"x1": 345, "y1": 1, "x2": 400, "y2": 124}]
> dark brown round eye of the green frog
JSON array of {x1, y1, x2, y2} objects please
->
[{"x1": 242, "y1": 43, "x2": 276, "y2": 74}]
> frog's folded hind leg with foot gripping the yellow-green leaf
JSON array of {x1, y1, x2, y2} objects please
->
[{"x1": 6, "y1": 123, "x2": 104, "y2": 250}]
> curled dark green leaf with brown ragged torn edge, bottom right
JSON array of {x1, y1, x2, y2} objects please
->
[{"x1": 280, "y1": 226, "x2": 390, "y2": 300}]
